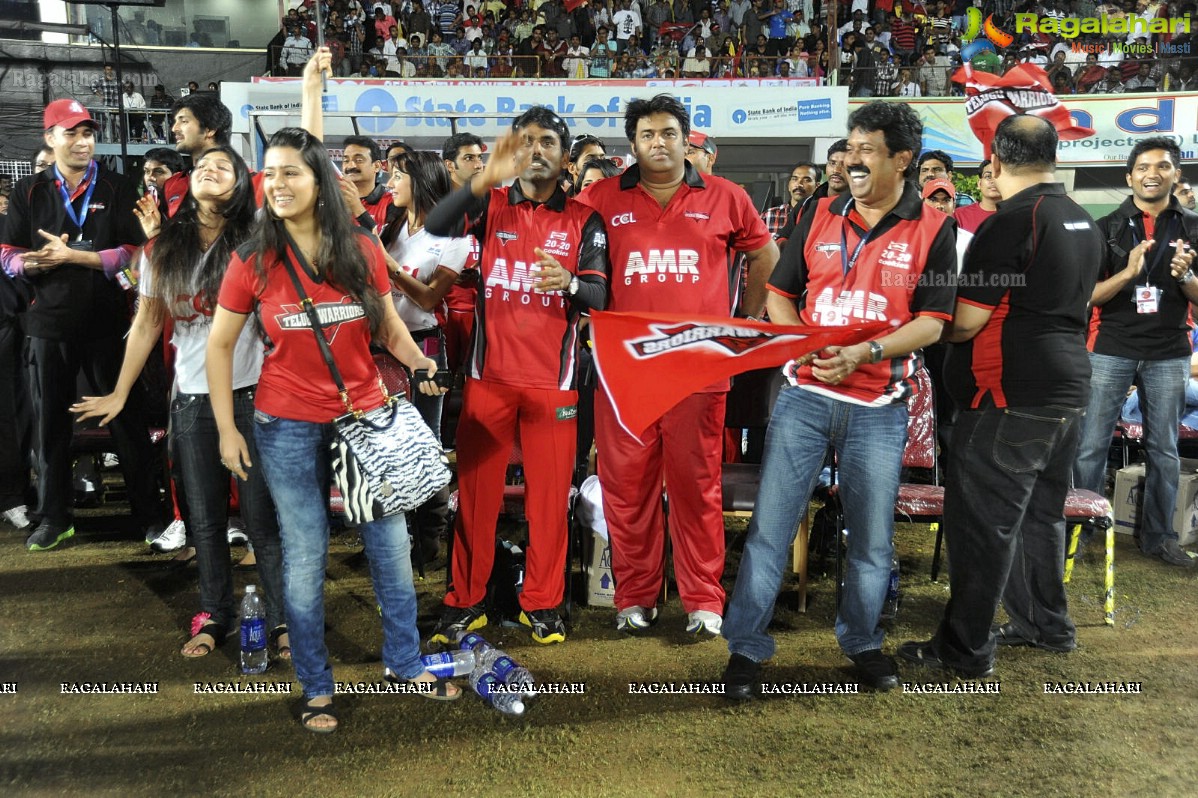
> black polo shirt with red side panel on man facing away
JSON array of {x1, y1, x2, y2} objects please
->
[{"x1": 944, "y1": 183, "x2": 1102, "y2": 410}]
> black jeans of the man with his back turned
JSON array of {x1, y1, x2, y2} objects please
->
[{"x1": 934, "y1": 407, "x2": 1084, "y2": 670}]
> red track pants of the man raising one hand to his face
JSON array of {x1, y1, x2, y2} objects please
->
[{"x1": 444, "y1": 379, "x2": 579, "y2": 610}]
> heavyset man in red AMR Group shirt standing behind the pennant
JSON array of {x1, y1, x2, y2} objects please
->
[{"x1": 581, "y1": 95, "x2": 781, "y2": 637}]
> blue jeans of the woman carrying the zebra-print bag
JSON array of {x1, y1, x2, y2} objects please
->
[{"x1": 254, "y1": 410, "x2": 424, "y2": 697}]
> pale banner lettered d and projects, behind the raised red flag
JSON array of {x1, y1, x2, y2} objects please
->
[{"x1": 896, "y1": 93, "x2": 1198, "y2": 167}]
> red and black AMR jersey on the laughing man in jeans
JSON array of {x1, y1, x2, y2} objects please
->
[{"x1": 769, "y1": 183, "x2": 957, "y2": 405}]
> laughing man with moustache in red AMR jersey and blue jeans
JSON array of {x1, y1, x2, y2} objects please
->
[{"x1": 722, "y1": 102, "x2": 956, "y2": 700}]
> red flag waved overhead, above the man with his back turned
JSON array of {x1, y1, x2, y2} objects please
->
[{"x1": 952, "y1": 64, "x2": 1094, "y2": 158}]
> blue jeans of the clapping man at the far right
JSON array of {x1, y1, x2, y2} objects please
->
[{"x1": 1073, "y1": 352, "x2": 1190, "y2": 552}]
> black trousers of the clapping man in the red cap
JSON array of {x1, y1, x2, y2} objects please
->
[{"x1": 29, "y1": 338, "x2": 163, "y2": 531}]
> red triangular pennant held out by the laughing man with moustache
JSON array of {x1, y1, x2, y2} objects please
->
[{"x1": 591, "y1": 313, "x2": 890, "y2": 439}]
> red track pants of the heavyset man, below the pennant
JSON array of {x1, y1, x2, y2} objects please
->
[{"x1": 595, "y1": 391, "x2": 726, "y2": 615}]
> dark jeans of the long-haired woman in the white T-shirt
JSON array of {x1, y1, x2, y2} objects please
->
[{"x1": 170, "y1": 388, "x2": 286, "y2": 629}]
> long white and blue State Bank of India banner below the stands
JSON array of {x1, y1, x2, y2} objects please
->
[{"x1": 220, "y1": 78, "x2": 848, "y2": 139}]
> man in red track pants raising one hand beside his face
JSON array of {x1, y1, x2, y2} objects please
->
[{"x1": 425, "y1": 105, "x2": 609, "y2": 645}]
